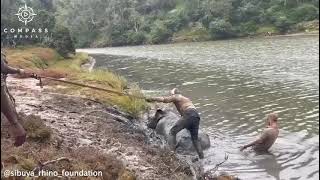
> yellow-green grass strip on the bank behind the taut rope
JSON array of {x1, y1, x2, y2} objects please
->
[{"x1": 5, "y1": 47, "x2": 147, "y2": 117}]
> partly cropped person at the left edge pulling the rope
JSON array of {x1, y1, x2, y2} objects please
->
[{"x1": 1, "y1": 51, "x2": 27, "y2": 146}]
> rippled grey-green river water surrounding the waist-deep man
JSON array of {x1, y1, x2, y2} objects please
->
[{"x1": 79, "y1": 36, "x2": 319, "y2": 180}]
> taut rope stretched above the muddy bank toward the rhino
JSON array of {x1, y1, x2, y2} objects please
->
[{"x1": 31, "y1": 74, "x2": 146, "y2": 99}]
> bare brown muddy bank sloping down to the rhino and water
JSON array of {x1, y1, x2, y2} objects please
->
[{"x1": 2, "y1": 77, "x2": 202, "y2": 180}]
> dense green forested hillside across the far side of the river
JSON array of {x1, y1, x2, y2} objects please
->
[{"x1": 1, "y1": 0, "x2": 319, "y2": 47}]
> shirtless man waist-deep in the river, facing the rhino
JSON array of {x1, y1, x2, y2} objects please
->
[{"x1": 240, "y1": 113, "x2": 279, "y2": 152}]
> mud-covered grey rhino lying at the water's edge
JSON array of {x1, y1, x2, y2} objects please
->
[{"x1": 147, "y1": 109, "x2": 210, "y2": 152}]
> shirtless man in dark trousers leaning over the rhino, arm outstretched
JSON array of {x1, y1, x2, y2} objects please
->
[{"x1": 147, "y1": 88, "x2": 203, "y2": 159}]
